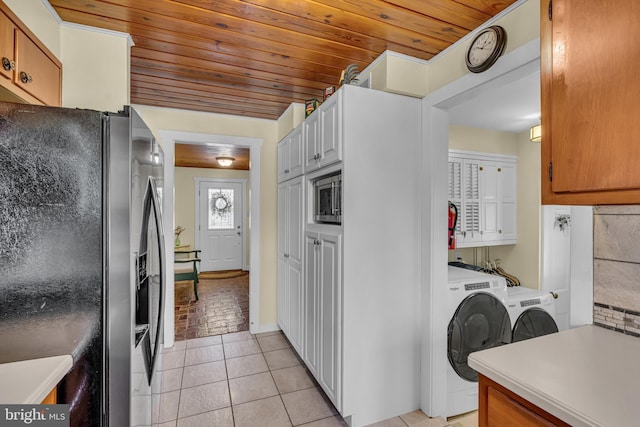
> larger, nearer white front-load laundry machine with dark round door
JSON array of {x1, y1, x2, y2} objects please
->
[{"x1": 447, "y1": 266, "x2": 511, "y2": 417}]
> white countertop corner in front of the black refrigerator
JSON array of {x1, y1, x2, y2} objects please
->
[{"x1": 0, "y1": 355, "x2": 73, "y2": 404}]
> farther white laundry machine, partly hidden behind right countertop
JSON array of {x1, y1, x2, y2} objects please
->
[{"x1": 505, "y1": 286, "x2": 558, "y2": 342}]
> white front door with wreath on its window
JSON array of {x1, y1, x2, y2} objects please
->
[{"x1": 198, "y1": 181, "x2": 244, "y2": 271}]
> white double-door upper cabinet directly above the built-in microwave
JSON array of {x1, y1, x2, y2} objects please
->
[{"x1": 302, "y1": 91, "x2": 343, "y2": 173}]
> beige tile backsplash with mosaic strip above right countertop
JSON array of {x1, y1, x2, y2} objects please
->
[{"x1": 593, "y1": 205, "x2": 640, "y2": 337}]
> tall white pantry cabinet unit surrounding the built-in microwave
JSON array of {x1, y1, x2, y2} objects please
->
[{"x1": 278, "y1": 85, "x2": 422, "y2": 427}]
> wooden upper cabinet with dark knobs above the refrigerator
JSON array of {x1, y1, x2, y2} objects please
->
[{"x1": 0, "y1": 1, "x2": 62, "y2": 106}]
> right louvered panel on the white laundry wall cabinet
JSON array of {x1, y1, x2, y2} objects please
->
[{"x1": 461, "y1": 160, "x2": 482, "y2": 244}]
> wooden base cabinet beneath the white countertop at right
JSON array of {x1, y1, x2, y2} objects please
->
[{"x1": 478, "y1": 375, "x2": 569, "y2": 427}]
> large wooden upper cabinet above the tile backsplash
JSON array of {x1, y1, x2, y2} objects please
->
[{"x1": 540, "y1": 0, "x2": 640, "y2": 205}]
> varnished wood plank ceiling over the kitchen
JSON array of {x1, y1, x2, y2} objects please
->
[{"x1": 49, "y1": 0, "x2": 515, "y2": 119}]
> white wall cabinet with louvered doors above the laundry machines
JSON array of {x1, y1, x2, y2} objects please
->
[{"x1": 448, "y1": 150, "x2": 517, "y2": 248}]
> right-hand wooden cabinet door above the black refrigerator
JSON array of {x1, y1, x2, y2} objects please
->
[{"x1": 14, "y1": 31, "x2": 61, "y2": 105}]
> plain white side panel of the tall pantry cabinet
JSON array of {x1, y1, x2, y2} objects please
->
[{"x1": 322, "y1": 85, "x2": 422, "y2": 426}]
